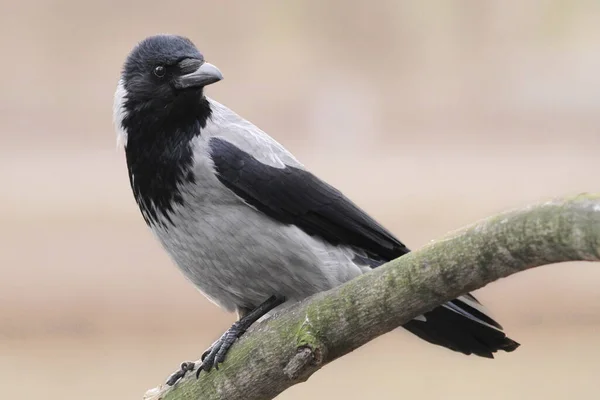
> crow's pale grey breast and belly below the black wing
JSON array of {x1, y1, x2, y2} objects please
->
[{"x1": 148, "y1": 134, "x2": 365, "y2": 311}]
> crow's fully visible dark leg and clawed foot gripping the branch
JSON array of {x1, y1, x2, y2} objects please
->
[{"x1": 196, "y1": 296, "x2": 285, "y2": 378}]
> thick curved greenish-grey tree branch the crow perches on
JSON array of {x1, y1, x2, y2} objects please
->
[{"x1": 145, "y1": 195, "x2": 600, "y2": 400}]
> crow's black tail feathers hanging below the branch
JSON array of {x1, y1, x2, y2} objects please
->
[{"x1": 404, "y1": 294, "x2": 519, "y2": 358}]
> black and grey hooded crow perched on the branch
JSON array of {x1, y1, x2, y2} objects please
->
[{"x1": 113, "y1": 34, "x2": 520, "y2": 385}]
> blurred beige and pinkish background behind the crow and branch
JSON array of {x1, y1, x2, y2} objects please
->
[{"x1": 0, "y1": 0, "x2": 600, "y2": 400}]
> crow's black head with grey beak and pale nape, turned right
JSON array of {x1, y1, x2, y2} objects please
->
[{"x1": 113, "y1": 35, "x2": 223, "y2": 144}]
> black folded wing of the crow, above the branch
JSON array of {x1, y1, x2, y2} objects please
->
[{"x1": 209, "y1": 138, "x2": 409, "y2": 261}]
